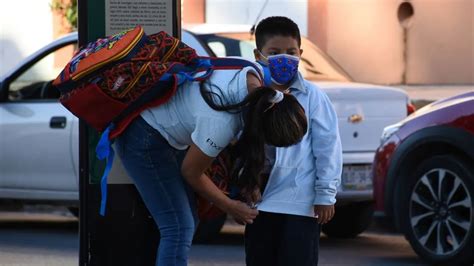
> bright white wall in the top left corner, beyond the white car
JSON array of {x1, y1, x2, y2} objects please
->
[{"x1": 0, "y1": 0, "x2": 53, "y2": 76}]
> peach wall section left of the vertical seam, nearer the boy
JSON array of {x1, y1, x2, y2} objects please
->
[{"x1": 309, "y1": 0, "x2": 403, "y2": 84}]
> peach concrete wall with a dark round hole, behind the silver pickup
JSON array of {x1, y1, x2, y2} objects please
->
[{"x1": 308, "y1": 0, "x2": 474, "y2": 84}]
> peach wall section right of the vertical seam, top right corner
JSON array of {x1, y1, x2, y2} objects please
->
[{"x1": 406, "y1": 0, "x2": 474, "y2": 84}]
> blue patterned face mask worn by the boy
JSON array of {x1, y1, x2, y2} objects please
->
[{"x1": 258, "y1": 51, "x2": 300, "y2": 86}]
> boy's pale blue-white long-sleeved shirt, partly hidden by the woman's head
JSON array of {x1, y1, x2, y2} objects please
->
[{"x1": 258, "y1": 73, "x2": 342, "y2": 217}]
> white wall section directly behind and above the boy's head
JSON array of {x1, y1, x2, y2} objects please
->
[{"x1": 205, "y1": 0, "x2": 308, "y2": 36}]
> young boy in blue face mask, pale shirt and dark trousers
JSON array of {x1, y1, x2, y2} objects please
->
[{"x1": 245, "y1": 17, "x2": 342, "y2": 266}]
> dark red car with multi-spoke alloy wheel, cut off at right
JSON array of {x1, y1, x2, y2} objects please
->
[{"x1": 373, "y1": 92, "x2": 474, "y2": 265}]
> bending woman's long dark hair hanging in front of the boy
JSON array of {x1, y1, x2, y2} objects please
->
[{"x1": 200, "y1": 84, "x2": 308, "y2": 196}]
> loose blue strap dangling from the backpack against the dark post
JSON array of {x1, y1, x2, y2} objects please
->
[{"x1": 95, "y1": 124, "x2": 114, "y2": 216}]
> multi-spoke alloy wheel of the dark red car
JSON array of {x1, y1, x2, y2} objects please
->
[{"x1": 398, "y1": 155, "x2": 474, "y2": 265}]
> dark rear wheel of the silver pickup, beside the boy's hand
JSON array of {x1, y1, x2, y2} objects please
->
[{"x1": 322, "y1": 202, "x2": 374, "y2": 238}]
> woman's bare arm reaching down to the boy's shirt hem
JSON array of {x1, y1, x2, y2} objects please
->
[{"x1": 181, "y1": 144, "x2": 258, "y2": 224}]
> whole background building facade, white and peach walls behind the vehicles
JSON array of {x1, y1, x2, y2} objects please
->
[{"x1": 0, "y1": 0, "x2": 474, "y2": 85}]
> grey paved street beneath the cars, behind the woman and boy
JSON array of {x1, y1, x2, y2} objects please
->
[{"x1": 0, "y1": 208, "x2": 425, "y2": 266}]
